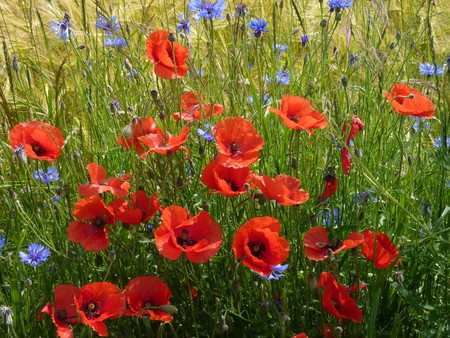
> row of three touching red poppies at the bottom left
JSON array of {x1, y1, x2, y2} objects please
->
[{"x1": 37, "y1": 276, "x2": 176, "y2": 338}]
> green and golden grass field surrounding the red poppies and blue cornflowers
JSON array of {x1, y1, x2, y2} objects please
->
[{"x1": 0, "y1": 0, "x2": 450, "y2": 337}]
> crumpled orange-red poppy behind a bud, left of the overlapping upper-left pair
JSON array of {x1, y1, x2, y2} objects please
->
[{"x1": 117, "y1": 117, "x2": 162, "y2": 154}]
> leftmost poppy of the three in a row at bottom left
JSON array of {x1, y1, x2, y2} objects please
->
[{"x1": 38, "y1": 285, "x2": 78, "y2": 338}]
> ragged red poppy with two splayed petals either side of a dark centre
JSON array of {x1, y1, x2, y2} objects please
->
[{"x1": 303, "y1": 226, "x2": 364, "y2": 261}]
